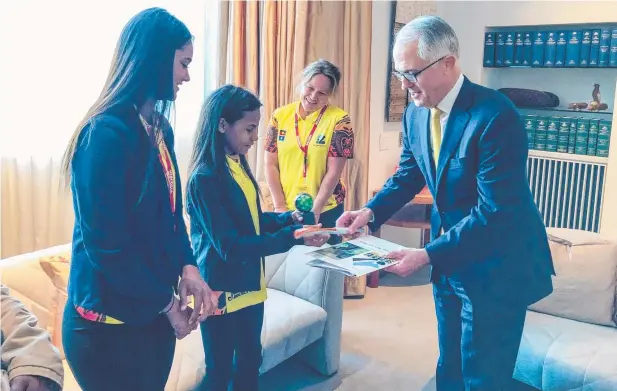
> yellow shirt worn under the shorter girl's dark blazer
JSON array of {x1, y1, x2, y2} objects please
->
[{"x1": 217, "y1": 156, "x2": 267, "y2": 314}]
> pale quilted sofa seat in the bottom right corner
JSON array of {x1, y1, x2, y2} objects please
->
[{"x1": 514, "y1": 311, "x2": 617, "y2": 391}]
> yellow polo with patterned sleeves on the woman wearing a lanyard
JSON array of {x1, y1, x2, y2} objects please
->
[{"x1": 266, "y1": 102, "x2": 354, "y2": 213}]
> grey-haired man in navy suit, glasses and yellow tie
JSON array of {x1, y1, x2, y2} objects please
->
[{"x1": 337, "y1": 16, "x2": 554, "y2": 391}]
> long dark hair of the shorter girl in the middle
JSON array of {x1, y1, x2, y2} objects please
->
[{"x1": 189, "y1": 84, "x2": 262, "y2": 192}]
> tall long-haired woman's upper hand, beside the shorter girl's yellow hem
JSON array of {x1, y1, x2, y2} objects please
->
[{"x1": 178, "y1": 265, "x2": 220, "y2": 323}]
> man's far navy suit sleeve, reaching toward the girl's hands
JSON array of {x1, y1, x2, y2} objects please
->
[{"x1": 366, "y1": 106, "x2": 426, "y2": 231}]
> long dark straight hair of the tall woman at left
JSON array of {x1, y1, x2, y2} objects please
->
[{"x1": 62, "y1": 7, "x2": 193, "y2": 184}]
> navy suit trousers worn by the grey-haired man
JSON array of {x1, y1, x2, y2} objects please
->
[{"x1": 433, "y1": 274, "x2": 527, "y2": 391}]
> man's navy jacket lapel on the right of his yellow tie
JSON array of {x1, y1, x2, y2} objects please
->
[{"x1": 435, "y1": 78, "x2": 473, "y2": 189}]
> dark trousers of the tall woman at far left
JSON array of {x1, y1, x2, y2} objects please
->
[{"x1": 62, "y1": 301, "x2": 176, "y2": 391}]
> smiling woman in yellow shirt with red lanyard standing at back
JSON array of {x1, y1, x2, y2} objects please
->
[{"x1": 265, "y1": 60, "x2": 354, "y2": 244}]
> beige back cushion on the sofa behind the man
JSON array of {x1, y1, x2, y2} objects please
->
[{"x1": 529, "y1": 228, "x2": 617, "y2": 326}]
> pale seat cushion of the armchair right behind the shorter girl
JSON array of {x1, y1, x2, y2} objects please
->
[{"x1": 261, "y1": 289, "x2": 327, "y2": 373}]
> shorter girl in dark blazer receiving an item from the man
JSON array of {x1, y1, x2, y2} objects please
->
[{"x1": 187, "y1": 85, "x2": 329, "y2": 391}]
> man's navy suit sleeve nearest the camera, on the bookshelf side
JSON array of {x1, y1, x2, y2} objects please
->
[{"x1": 426, "y1": 110, "x2": 528, "y2": 273}]
